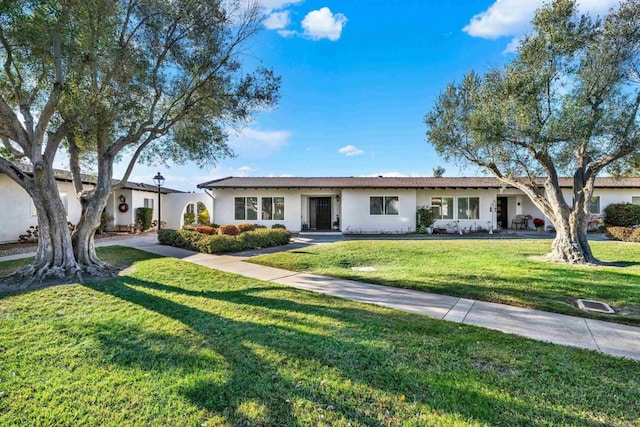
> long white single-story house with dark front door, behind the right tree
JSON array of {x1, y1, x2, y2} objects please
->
[{"x1": 198, "y1": 177, "x2": 640, "y2": 234}]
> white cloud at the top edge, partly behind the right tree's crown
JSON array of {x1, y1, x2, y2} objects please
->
[{"x1": 462, "y1": 0, "x2": 619, "y2": 41}]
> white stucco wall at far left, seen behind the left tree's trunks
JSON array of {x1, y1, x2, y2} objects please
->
[{"x1": 0, "y1": 174, "x2": 90, "y2": 242}]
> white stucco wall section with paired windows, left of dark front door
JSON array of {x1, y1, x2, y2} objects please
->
[{"x1": 212, "y1": 188, "x2": 302, "y2": 232}]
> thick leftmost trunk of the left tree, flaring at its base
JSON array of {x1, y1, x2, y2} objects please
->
[{"x1": 4, "y1": 167, "x2": 82, "y2": 289}]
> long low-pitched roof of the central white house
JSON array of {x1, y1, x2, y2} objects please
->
[{"x1": 198, "y1": 176, "x2": 640, "y2": 189}]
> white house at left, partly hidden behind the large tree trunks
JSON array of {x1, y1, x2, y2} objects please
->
[{"x1": 0, "y1": 163, "x2": 213, "y2": 243}]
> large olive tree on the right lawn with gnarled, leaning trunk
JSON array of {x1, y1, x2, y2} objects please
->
[{"x1": 425, "y1": 0, "x2": 640, "y2": 263}]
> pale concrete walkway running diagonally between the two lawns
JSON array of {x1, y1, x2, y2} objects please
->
[{"x1": 0, "y1": 235, "x2": 640, "y2": 360}]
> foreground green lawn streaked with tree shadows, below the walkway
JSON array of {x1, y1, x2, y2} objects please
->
[{"x1": 0, "y1": 249, "x2": 640, "y2": 426}]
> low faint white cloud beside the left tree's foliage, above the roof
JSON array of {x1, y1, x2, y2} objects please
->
[{"x1": 229, "y1": 128, "x2": 291, "y2": 159}]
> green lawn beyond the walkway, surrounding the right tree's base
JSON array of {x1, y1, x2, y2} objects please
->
[{"x1": 251, "y1": 239, "x2": 640, "y2": 324}]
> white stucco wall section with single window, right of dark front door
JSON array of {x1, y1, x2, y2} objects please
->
[{"x1": 340, "y1": 189, "x2": 417, "y2": 234}]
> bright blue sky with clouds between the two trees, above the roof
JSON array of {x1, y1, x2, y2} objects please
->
[{"x1": 115, "y1": 0, "x2": 616, "y2": 191}]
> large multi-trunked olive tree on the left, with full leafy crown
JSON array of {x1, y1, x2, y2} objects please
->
[{"x1": 0, "y1": 0, "x2": 279, "y2": 288}]
